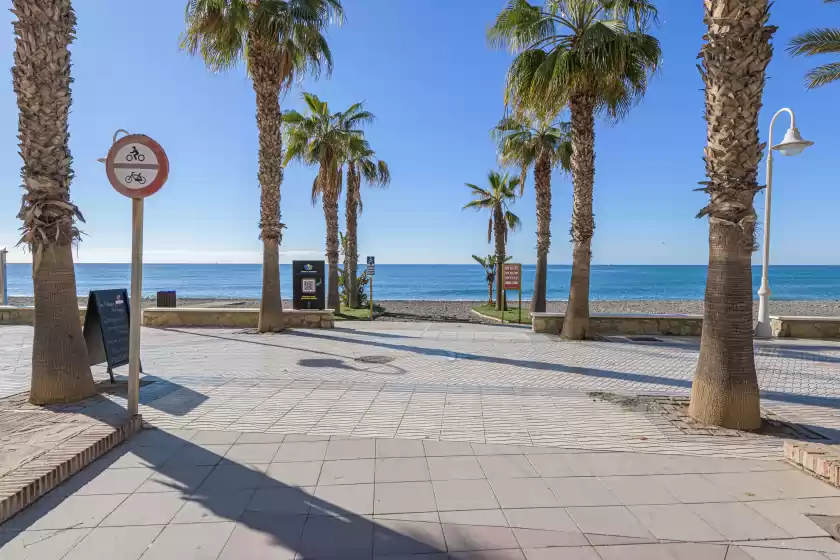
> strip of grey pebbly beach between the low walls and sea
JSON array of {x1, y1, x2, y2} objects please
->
[{"x1": 9, "y1": 297, "x2": 840, "y2": 322}]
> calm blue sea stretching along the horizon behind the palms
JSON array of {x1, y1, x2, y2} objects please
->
[{"x1": 8, "y1": 264, "x2": 840, "y2": 301}]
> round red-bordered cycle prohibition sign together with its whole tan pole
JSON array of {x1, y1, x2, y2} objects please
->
[{"x1": 105, "y1": 130, "x2": 169, "y2": 416}]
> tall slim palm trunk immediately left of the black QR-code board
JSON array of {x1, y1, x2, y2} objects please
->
[{"x1": 248, "y1": 43, "x2": 284, "y2": 332}]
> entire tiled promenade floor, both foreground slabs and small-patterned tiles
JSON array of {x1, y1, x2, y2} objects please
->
[{"x1": 0, "y1": 322, "x2": 840, "y2": 560}]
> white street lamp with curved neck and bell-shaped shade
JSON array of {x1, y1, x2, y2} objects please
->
[{"x1": 755, "y1": 109, "x2": 814, "y2": 338}]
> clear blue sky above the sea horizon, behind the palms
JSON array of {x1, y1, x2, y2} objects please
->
[{"x1": 0, "y1": 0, "x2": 840, "y2": 264}]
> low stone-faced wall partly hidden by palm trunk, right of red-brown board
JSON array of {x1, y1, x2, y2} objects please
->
[{"x1": 531, "y1": 313, "x2": 703, "y2": 336}]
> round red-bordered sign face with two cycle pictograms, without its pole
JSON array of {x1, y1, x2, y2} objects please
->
[{"x1": 105, "y1": 134, "x2": 169, "y2": 198}]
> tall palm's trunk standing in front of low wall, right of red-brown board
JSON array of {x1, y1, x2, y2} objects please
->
[{"x1": 561, "y1": 93, "x2": 595, "y2": 340}]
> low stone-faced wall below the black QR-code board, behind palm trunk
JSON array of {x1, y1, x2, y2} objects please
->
[{"x1": 143, "y1": 307, "x2": 334, "y2": 329}]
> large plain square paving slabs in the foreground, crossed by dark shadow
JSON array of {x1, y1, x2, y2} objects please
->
[{"x1": 0, "y1": 430, "x2": 840, "y2": 560}]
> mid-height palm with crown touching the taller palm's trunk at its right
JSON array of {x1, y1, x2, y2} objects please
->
[{"x1": 493, "y1": 113, "x2": 572, "y2": 312}]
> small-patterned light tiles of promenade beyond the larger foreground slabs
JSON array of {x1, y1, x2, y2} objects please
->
[{"x1": 0, "y1": 322, "x2": 840, "y2": 458}]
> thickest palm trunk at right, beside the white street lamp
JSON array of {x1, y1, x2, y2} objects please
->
[{"x1": 689, "y1": 0, "x2": 776, "y2": 429}]
